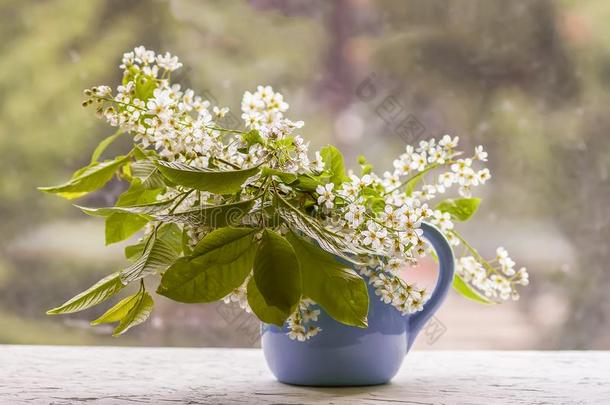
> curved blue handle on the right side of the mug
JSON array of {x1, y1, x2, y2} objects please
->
[{"x1": 406, "y1": 223, "x2": 455, "y2": 349}]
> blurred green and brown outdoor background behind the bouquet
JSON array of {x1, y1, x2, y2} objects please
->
[{"x1": 0, "y1": 0, "x2": 610, "y2": 349}]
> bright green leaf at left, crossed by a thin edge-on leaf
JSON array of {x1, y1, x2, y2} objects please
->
[{"x1": 106, "y1": 179, "x2": 160, "y2": 245}]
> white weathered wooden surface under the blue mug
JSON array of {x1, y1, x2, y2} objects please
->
[{"x1": 0, "y1": 346, "x2": 610, "y2": 405}]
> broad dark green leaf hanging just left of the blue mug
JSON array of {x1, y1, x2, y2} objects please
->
[{"x1": 157, "y1": 228, "x2": 257, "y2": 303}]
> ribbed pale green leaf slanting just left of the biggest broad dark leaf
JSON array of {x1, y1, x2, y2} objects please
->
[{"x1": 121, "y1": 227, "x2": 181, "y2": 284}]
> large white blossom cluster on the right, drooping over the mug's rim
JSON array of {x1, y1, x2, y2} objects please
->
[{"x1": 304, "y1": 135, "x2": 498, "y2": 314}]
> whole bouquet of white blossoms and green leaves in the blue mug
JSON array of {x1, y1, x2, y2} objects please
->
[{"x1": 41, "y1": 46, "x2": 528, "y2": 341}]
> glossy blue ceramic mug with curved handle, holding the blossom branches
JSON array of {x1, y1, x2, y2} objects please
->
[{"x1": 261, "y1": 224, "x2": 454, "y2": 386}]
